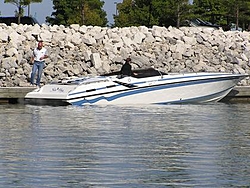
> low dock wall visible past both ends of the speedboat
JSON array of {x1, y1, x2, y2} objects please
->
[{"x1": 0, "y1": 86, "x2": 250, "y2": 104}]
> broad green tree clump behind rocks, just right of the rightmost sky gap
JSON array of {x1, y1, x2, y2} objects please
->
[{"x1": 114, "y1": 0, "x2": 191, "y2": 27}]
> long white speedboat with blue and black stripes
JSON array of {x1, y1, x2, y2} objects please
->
[{"x1": 25, "y1": 68, "x2": 249, "y2": 106}]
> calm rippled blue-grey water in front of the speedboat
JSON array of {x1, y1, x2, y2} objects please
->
[{"x1": 0, "y1": 103, "x2": 250, "y2": 188}]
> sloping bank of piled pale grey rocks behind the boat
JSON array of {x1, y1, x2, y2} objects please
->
[{"x1": 0, "y1": 24, "x2": 250, "y2": 87}]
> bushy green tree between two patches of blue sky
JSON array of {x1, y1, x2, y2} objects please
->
[{"x1": 46, "y1": 0, "x2": 108, "y2": 26}]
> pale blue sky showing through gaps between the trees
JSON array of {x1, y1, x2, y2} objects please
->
[{"x1": 0, "y1": 0, "x2": 123, "y2": 24}]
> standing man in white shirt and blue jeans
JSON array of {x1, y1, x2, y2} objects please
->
[{"x1": 31, "y1": 41, "x2": 48, "y2": 87}]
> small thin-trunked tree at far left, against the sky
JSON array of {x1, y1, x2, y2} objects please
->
[{"x1": 4, "y1": 0, "x2": 42, "y2": 24}]
